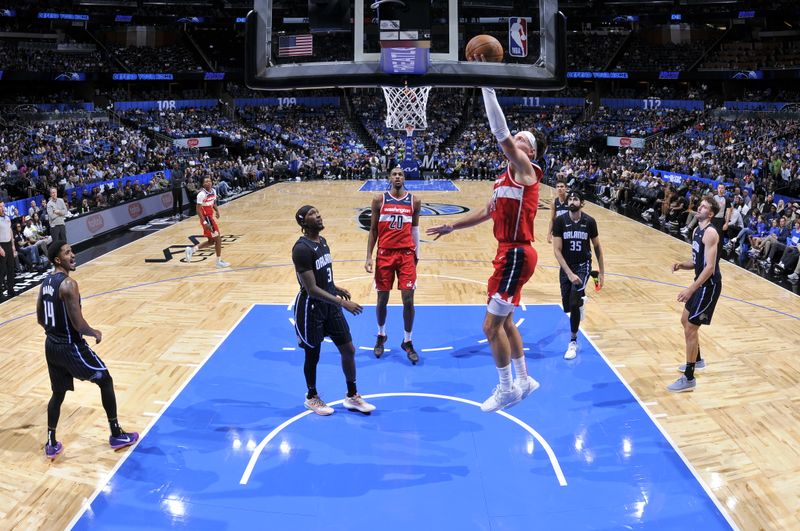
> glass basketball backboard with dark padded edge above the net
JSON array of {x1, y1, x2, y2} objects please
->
[{"x1": 245, "y1": 0, "x2": 566, "y2": 90}]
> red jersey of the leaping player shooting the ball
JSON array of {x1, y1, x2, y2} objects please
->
[{"x1": 492, "y1": 163, "x2": 544, "y2": 243}]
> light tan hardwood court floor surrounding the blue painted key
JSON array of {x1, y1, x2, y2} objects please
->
[{"x1": 0, "y1": 182, "x2": 800, "y2": 530}]
